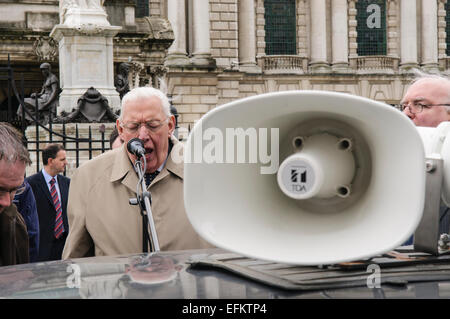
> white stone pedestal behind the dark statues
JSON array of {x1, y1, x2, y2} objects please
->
[{"x1": 50, "y1": 17, "x2": 121, "y2": 115}]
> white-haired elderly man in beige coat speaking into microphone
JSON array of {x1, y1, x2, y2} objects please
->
[{"x1": 63, "y1": 87, "x2": 211, "y2": 259}]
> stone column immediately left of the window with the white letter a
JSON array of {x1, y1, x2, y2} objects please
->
[{"x1": 331, "y1": 0, "x2": 349, "y2": 72}]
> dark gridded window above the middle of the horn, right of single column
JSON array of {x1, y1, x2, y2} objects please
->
[{"x1": 264, "y1": 0, "x2": 297, "y2": 55}]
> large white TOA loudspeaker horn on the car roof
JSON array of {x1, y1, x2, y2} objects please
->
[{"x1": 184, "y1": 91, "x2": 425, "y2": 265}]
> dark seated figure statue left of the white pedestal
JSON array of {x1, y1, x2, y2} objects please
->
[{"x1": 17, "y1": 63, "x2": 60, "y2": 125}]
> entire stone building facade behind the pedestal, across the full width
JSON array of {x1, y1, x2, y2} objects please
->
[{"x1": 0, "y1": 0, "x2": 450, "y2": 132}]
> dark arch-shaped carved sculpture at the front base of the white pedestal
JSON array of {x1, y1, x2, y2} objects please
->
[{"x1": 55, "y1": 87, "x2": 118, "y2": 123}]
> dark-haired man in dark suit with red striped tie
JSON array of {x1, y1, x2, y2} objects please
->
[{"x1": 27, "y1": 144, "x2": 70, "y2": 261}]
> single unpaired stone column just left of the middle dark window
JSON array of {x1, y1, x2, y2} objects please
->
[{"x1": 238, "y1": 0, "x2": 261, "y2": 73}]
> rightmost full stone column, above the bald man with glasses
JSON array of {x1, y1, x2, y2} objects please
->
[{"x1": 422, "y1": 0, "x2": 439, "y2": 72}]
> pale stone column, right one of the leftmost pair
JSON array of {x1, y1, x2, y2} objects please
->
[{"x1": 191, "y1": 0, "x2": 215, "y2": 66}]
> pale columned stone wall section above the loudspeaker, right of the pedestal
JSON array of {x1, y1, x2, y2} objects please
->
[{"x1": 163, "y1": 0, "x2": 449, "y2": 132}]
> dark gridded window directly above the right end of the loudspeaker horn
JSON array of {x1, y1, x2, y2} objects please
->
[{"x1": 356, "y1": 0, "x2": 387, "y2": 56}]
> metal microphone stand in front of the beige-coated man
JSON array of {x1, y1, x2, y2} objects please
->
[{"x1": 130, "y1": 156, "x2": 160, "y2": 252}]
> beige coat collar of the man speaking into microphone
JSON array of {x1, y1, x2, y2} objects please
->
[{"x1": 110, "y1": 136, "x2": 184, "y2": 192}]
